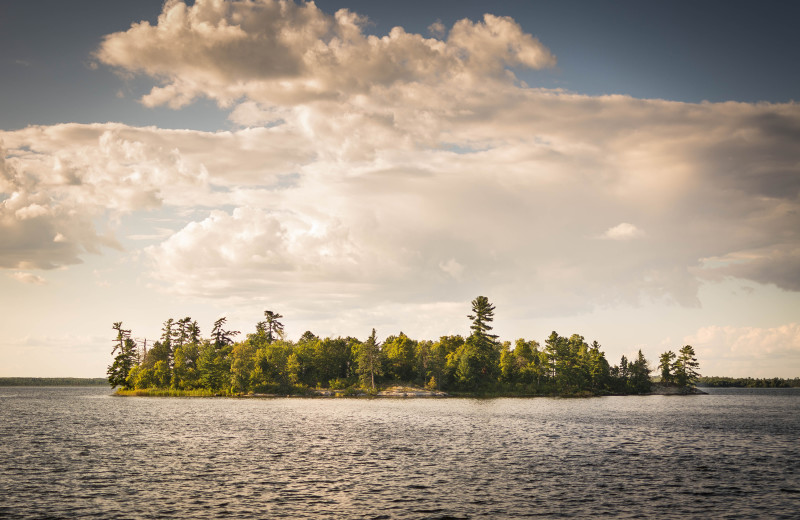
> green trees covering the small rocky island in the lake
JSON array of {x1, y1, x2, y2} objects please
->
[{"x1": 108, "y1": 296, "x2": 699, "y2": 395}]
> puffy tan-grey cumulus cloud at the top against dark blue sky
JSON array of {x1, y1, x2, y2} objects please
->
[{"x1": 96, "y1": 0, "x2": 555, "y2": 108}]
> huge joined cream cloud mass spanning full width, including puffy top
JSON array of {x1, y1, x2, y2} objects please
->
[{"x1": 0, "y1": 1, "x2": 800, "y2": 324}]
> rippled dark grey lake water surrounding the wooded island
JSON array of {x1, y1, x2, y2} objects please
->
[{"x1": 0, "y1": 387, "x2": 800, "y2": 519}]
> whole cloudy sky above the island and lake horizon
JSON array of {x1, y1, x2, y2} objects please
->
[{"x1": 0, "y1": 0, "x2": 800, "y2": 377}]
